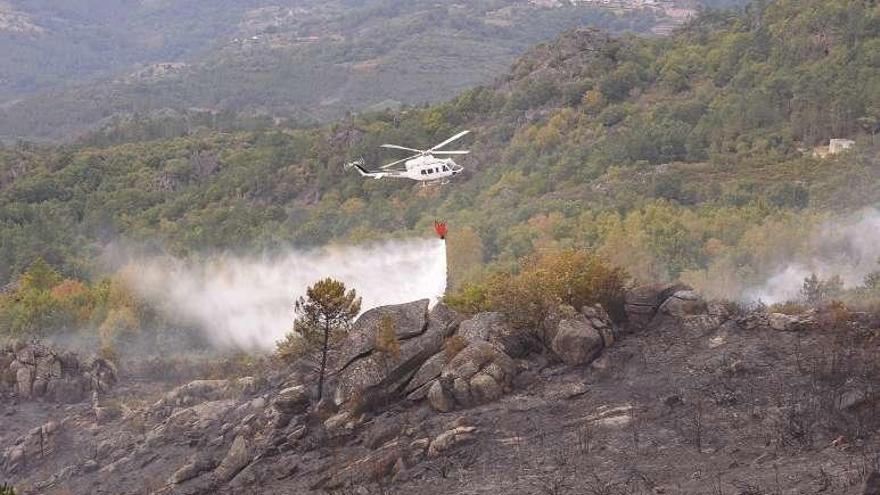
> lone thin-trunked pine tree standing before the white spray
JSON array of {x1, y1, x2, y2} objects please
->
[{"x1": 293, "y1": 278, "x2": 361, "y2": 400}]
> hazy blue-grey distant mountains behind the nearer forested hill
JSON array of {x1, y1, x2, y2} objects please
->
[{"x1": 0, "y1": 0, "x2": 720, "y2": 139}]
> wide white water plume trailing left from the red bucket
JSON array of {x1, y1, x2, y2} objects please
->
[{"x1": 129, "y1": 239, "x2": 446, "y2": 350}]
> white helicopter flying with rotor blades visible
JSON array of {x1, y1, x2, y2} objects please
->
[{"x1": 345, "y1": 131, "x2": 471, "y2": 184}]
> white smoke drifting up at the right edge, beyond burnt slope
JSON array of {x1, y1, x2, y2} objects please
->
[{"x1": 745, "y1": 208, "x2": 880, "y2": 304}]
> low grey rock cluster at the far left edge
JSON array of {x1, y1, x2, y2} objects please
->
[{"x1": 0, "y1": 343, "x2": 116, "y2": 404}]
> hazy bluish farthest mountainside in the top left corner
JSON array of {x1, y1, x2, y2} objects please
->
[{"x1": 0, "y1": 0, "x2": 276, "y2": 101}]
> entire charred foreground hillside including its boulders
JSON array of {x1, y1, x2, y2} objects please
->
[{"x1": 0, "y1": 286, "x2": 880, "y2": 495}]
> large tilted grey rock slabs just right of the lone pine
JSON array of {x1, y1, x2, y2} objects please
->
[{"x1": 335, "y1": 302, "x2": 461, "y2": 408}]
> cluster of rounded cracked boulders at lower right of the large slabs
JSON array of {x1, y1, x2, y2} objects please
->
[{"x1": 428, "y1": 341, "x2": 516, "y2": 412}]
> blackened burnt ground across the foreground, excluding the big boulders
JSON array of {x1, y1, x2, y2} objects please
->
[{"x1": 0, "y1": 316, "x2": 880, "y2": 495}]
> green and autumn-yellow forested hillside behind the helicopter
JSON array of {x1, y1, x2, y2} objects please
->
[{"x1": 0, "y1": 0, "x2": 880, "y2": 344}]
